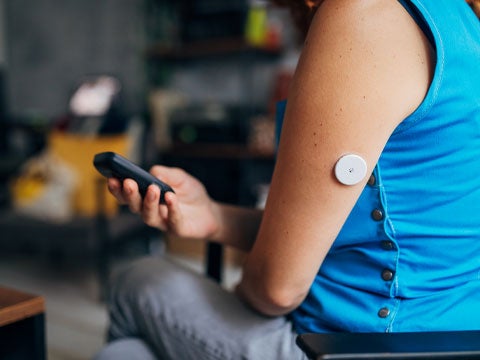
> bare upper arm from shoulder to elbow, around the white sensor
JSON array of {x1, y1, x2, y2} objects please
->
[{"x1": 238, "y1": 0, "x2": 431, "y2": 312}]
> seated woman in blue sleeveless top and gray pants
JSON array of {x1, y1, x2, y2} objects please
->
[{"x1": 95, "y1": 0, "x2": 480, "y2": 359}]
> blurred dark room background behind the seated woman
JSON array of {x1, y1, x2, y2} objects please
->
[{"x1": 0, "y1": 0, "x2": 301, "y2": 359}]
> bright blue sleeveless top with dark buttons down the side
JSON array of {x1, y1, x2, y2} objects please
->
[{"x1": 279, "y1": 0, "x2": 480, "y2": 333}]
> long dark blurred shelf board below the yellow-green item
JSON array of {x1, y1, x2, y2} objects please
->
[{"x1": 147, "y1": 38, "x2": 282, "y2": 60}]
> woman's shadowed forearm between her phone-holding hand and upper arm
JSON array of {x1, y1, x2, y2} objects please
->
[{"x1": 208, "y1": 203, "x2": 263, "y2": 252}]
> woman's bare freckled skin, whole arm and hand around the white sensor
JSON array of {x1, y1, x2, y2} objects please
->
[{"x1": 108, "y1": 0, "x2": 442, "y2": 315}]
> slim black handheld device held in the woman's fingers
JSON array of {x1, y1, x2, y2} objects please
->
[{"x1": 93, "y1": 151, "x2": 175, "y2": 204}]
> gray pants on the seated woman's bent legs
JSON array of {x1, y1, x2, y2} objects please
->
[{"x1": 96, "y1": 258, "x2": 306, "y2": 360}]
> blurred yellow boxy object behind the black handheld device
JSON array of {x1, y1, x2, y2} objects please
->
[{"x1": 48, "y1": 131, "x2": 130, "y2": 216}]
